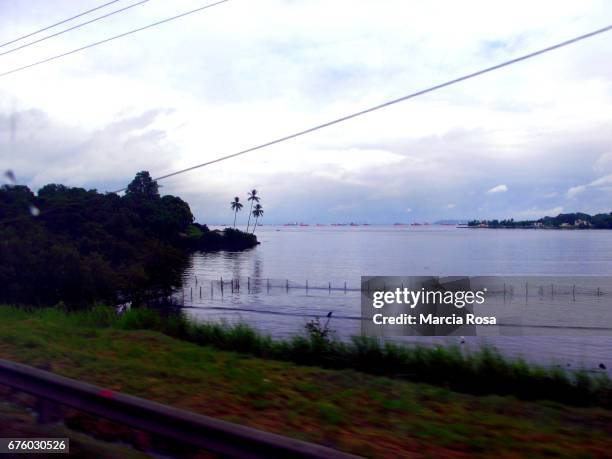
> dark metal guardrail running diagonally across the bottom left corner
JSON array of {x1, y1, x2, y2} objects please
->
[{"x1": 0, "y1": 359, "x2": 358, "y2": 459}]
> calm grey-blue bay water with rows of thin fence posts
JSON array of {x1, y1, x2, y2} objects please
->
[{"x1": 178, "y1": 225, "x2": 612, "y2": 371}]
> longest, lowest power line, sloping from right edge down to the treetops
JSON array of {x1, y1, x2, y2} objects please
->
[{"x1": 113, "y1": 25, "x2": 612, "y2": 193}]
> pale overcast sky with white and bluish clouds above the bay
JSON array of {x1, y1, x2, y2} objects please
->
[{"x1": 0, "y1": 0, "x2": 612, "y2": 223}]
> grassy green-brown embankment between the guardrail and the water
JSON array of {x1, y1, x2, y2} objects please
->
[{"x1": 0, "y1": 307, "x2": 612, "y2": 457}]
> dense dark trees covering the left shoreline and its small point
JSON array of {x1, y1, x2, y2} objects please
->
[{"x1": 0, "y1": 172, "x2": 257, "y2": 306}]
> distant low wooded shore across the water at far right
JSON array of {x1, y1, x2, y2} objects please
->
[{"x1": 468, "y1": 212, "x2": 612, "y2": 229}]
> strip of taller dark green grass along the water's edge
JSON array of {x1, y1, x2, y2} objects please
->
[{"x1": 0, "y1": 306, "x2": 612, "y2": 408}]
